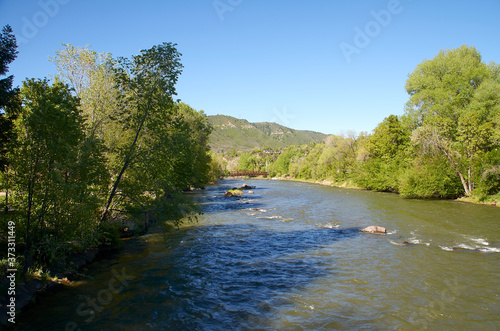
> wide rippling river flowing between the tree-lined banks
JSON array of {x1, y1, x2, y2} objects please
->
[{"x1": 17, "y1": 180, "x2": 500, "y2": 330}]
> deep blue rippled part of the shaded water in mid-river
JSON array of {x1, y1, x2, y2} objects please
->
[{"x1": 129, "y1": 225, "x2": 359, "y2": 330}]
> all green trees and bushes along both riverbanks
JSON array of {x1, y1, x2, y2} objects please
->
[{"x1": 0, "y1": 26, "x2": 500, "y2": 300}]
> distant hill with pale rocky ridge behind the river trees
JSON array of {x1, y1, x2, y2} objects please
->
[{"x1": 208, "y1": 115, "x2": 327, "y2": 153}]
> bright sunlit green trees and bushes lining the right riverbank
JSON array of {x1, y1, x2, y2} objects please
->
[{"x1": 219, "y1": 46, "x2": 500, "y2": 203}]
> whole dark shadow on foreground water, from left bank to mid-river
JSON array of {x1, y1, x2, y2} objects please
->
[{"x1": 18, "y1": 224, "x2": 359, "y2": 330}]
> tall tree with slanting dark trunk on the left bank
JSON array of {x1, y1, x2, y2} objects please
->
[{"x1": 101, "y1": 43, "x2": 182, "y2": 222}]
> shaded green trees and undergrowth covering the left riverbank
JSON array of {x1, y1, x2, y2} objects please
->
[{"x1": 0, "y1": 26, "x2": 220, "y2": 284}]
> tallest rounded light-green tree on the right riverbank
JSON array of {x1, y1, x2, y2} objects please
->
[{"x1": 406, "y1": 45, "x2": 498, "y2": 196}]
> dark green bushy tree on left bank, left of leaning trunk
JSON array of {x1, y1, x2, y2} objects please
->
[{"x1": 8, "y1": 79, "x2": 107, "y2": 273}]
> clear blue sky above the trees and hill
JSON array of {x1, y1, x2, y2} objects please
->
[{"x1": 0, "y1": 0, "x2": 500, "y2": 134}]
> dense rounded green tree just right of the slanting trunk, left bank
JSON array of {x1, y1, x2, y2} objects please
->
[{"x1": 122, "y1": 103, "x2": 211, "y2": 207}]
